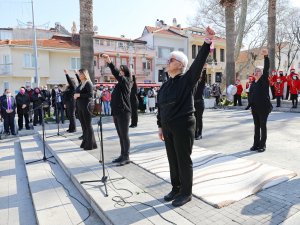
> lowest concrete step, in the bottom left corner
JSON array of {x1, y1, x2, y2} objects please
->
[{"x1": 0, "y1": 138, "x2": 37, "y2": 225}]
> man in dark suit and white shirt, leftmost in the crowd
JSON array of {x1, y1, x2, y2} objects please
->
[{"x1": 1, "y1": 89, "x2": 16, "y2": 135}]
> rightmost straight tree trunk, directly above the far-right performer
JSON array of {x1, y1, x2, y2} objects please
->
[{"x1": 268, "y1": 0, "x2": 276, "y2": 72}]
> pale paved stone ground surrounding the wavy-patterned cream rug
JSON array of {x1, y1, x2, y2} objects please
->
[{"x1": 62, "y1": 110, "x2": 300, "y2": 225}]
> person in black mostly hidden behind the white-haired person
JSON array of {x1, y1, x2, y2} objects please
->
[{"x1": 194, "y1": 68, "x2": 207, "y2": 140}]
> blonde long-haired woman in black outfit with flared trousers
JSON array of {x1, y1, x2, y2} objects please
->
[{"x1": 74, "y1": 69, "x2": 97, "y2": 150}]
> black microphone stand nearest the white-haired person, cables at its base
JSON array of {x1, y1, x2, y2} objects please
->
[{"x1": 80, "y1": 101, "x2": 108, "y2": 197}]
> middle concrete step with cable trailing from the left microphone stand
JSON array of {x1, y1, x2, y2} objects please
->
[{"x1": 20, "y1": 135, "x2": 103, "y2": 225}]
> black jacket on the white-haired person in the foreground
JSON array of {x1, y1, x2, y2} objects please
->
[{"x1": 157, "y1": 43, "x2": 210, "y2": 127}]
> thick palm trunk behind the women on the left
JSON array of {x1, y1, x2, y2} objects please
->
[{"x1": 79, "y1": 0, "x2": 95, "y2": 83}]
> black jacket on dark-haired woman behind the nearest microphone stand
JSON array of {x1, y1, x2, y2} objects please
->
[{"x1": 108, "y1": 63, "x2": 132, "y2": 116}]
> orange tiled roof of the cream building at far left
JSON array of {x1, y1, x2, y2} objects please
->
[{"x1": 0, "y1": 36, "x2": 79, "y2": 49}]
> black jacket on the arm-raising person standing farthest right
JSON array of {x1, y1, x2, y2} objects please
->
[{"x1": 249, "y1": 56, "x2": 273, "y2": 113}]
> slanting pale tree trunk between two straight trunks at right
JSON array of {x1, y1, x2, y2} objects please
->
[{"x1": 234, "y1": 0, "x2": 248, "y2": 60}]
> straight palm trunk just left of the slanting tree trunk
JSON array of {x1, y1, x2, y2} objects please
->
[{"x1": 220, "y1": 0, "x2": 236, "y2": 87}]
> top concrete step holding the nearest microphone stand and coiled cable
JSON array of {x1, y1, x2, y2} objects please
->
[{"x1": 41, "y1": 129, "x2": 191, "y2": 225}]
